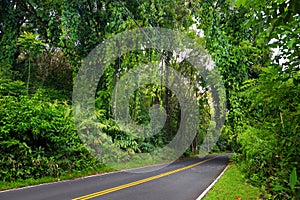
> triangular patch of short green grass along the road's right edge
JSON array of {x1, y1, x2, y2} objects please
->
[{"x1": 203, "y1": 164, "x2": 262, "y2": 200}]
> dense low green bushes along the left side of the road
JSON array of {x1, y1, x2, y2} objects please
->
[{"x1": 0, "y1": 91, "x2": 99, "y2": 181}]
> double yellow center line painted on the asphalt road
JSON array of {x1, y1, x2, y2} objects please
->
[{"x1": 73, "y1": 156, "x2": 218, "y2": 200}]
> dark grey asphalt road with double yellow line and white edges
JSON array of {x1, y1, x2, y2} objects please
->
[{"x1": 0, "y1": 154, "x2": 228, "y2": 200}]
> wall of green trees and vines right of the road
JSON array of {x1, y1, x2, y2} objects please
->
[{"x1": 193, "y1": 0, "x2": 300, "y2": 199}]
